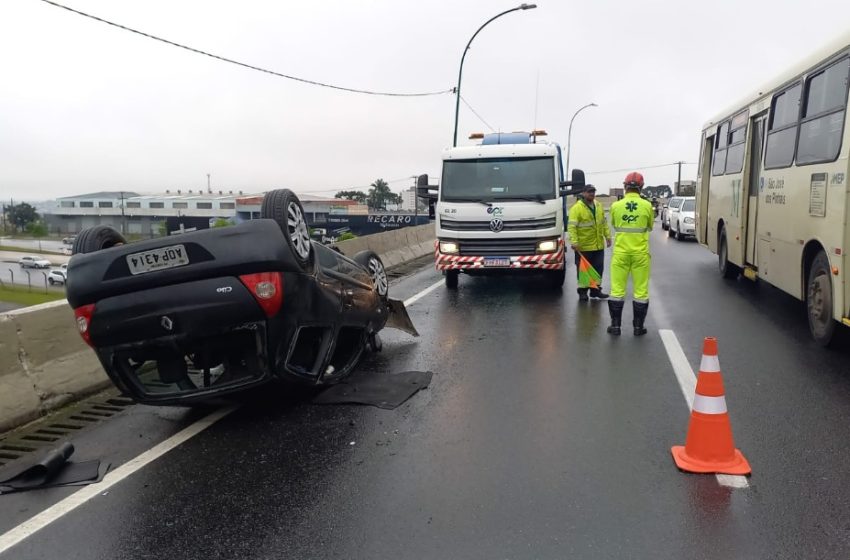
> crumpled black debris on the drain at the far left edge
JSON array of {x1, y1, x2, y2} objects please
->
[{"x1": 0, "y1": 442, "x2": 109, "y2": 494}]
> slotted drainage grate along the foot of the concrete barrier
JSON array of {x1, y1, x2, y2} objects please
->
[{"x1": 0, "y1": 389, "x2": 133, "y2": 467}]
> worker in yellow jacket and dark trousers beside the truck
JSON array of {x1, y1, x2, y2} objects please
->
[{"x1": 567, "y1": 185, "x2": 611, "y2": 301}]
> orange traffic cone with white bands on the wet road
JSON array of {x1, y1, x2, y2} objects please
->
[{"x1": 671, "y1": 337, "x2": 752, "y2": 475}]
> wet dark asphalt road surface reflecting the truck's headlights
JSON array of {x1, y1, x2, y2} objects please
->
[{"x1": 0, "y1": 225, "x2": 850, "y2": 560}]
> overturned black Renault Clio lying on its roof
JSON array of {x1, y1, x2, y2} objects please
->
[{"x1": 67, "y1": 189, "x2": 417, "y2": 404}]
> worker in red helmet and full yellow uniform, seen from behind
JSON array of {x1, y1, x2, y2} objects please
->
[{"x1": 608, "y1": 172, "x2": 655, "y2": 336}]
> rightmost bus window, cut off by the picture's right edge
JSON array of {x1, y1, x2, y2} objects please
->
[{"x1": 797, "y1": 58, "x2": 850, "y2": 164}]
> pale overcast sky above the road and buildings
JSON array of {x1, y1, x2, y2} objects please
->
[{"x1": 0, "y1": 0, "x2": 850, "y2": 200}]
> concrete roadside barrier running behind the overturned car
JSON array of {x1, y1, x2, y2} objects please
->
[{"x1": 0, "y1": 224, "x2": 435, "y2": 432}]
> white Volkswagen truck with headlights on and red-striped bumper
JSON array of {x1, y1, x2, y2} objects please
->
[{"x1": 435, "y1": 131, "x2": 584, "y2": 288}]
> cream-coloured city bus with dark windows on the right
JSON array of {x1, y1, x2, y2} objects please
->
[{"x1": 696, "y1": 33, "x2": 850, "y2": 346}]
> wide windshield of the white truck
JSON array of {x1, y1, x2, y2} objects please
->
[{"x1": 440, "y1": 157, "x2": 555, "y2": 202}]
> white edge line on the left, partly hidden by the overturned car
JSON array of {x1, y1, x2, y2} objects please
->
[{"x1": 0, "y1": 274, "x2": 443, "y2": 554}]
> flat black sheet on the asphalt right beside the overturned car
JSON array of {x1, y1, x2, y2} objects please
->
[{"x1": 313, "y1": 371, "x2": 434, "y2": 410}]
